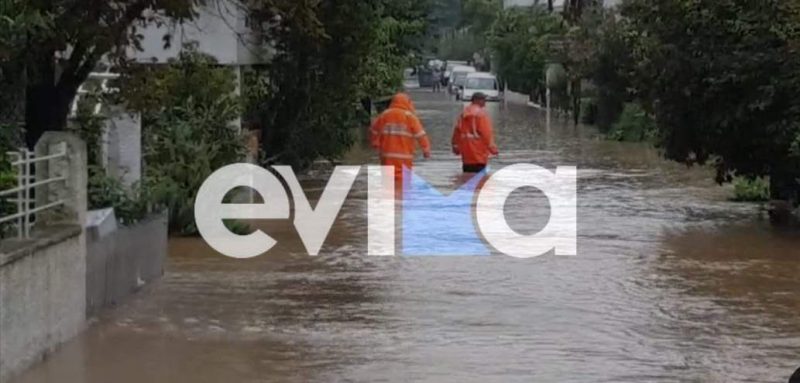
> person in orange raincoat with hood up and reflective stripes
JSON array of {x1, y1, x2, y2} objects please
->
[{"x1": 370, "y1": 93, "x2": 431, "y2": 179}]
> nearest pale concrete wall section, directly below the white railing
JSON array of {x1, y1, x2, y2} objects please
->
[{"x1": 0, "y1": 226, "x2": 86, "y2": 382}]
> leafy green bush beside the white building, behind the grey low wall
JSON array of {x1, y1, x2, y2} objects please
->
[{"x1": 121, "y1": 50, "x2": 244, "y2": 235}]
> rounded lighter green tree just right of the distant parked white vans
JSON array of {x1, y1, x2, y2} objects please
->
[{"x1": 489, "y1": 7, "x2": 565, "y2": 95}]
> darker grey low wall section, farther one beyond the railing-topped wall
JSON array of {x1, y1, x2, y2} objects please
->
[{"x1": 86, "y1": 213, "x2": 168, "y2": 316}]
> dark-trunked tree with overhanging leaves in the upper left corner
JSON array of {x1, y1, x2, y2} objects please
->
[{"x1": 0, "y1": 0, "x2": 200, "y2": 146}]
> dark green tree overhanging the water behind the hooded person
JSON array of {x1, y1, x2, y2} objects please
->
[{"x1": 248, "y1": 0, "x2": 425, "y2": 168}]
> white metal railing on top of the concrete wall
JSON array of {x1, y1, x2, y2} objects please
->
[{"x1": 0, "y1": 146, "x2": 67, "y2": 239}]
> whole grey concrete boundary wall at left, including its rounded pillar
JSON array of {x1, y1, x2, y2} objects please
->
[{"x1": 0, "y1": 132, "x2": 167, "y2": 382}]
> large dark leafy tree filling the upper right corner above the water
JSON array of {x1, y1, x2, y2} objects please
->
[{"x1": 621, "y1": 0, "x2": 800, "y2": 201}]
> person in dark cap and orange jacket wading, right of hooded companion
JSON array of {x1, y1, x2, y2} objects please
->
[{"x1": 453, "y1": 93, "x2": 499, "y2": 173}]
